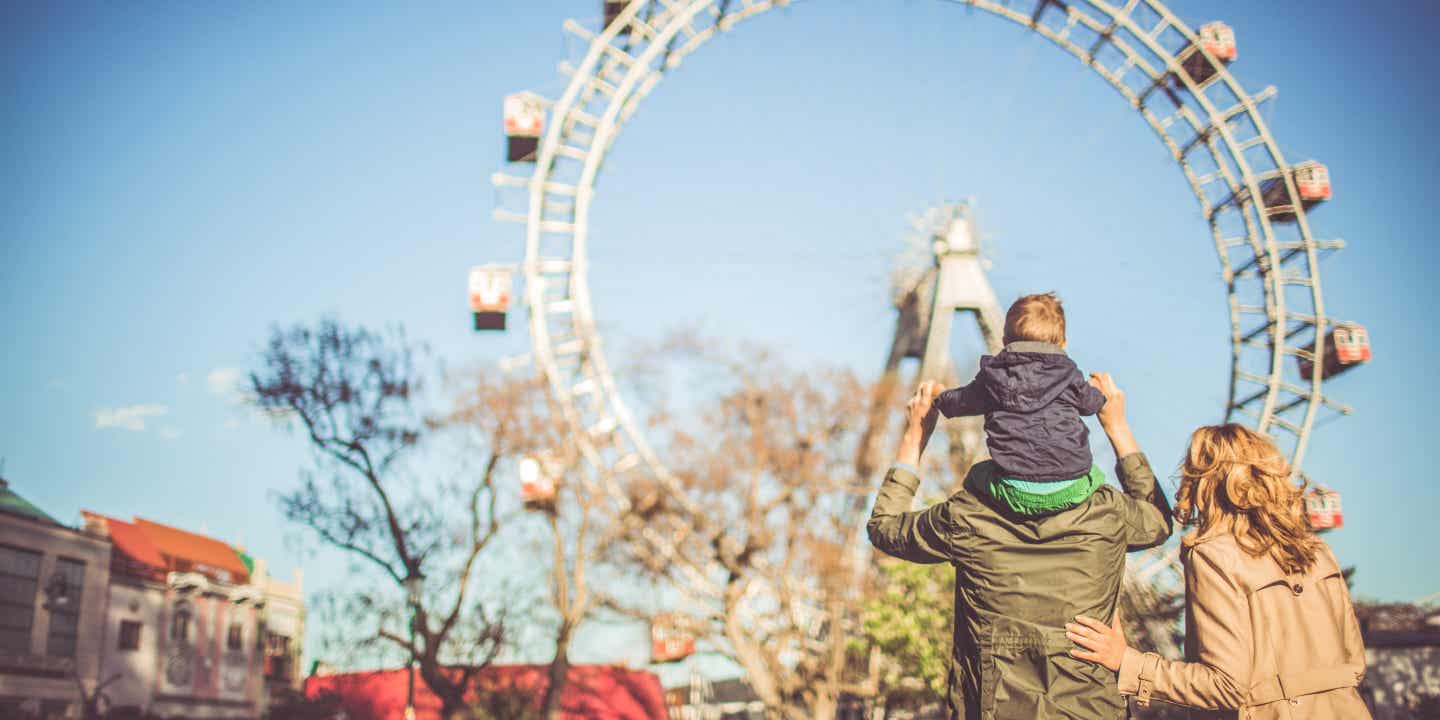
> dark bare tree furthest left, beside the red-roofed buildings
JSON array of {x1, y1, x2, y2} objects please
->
[{"x1": 251, "y1": 320, "x2": 547, "y2": 717}]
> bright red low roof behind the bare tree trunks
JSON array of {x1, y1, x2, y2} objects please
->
[{"x1": 305, "y1": 665, "x2": 667, "y2": 720}]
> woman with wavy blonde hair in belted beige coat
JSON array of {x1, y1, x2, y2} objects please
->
[{"x1": 1066, "y1": 425, "x2": 1369, "y2": 720}]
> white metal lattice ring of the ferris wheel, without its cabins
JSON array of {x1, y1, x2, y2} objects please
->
[{"x1": 494, "y1": 0, "x2": 1349, "y2": 624}]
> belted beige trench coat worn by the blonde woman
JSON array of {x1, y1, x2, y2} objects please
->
[{"x1": 1119, "y1": 533, "x2": 1369, "y2": 720}]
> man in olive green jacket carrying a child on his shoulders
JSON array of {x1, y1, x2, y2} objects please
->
[{"x1": 868, "y1": 373, "x2": 1172, "y2": 720}]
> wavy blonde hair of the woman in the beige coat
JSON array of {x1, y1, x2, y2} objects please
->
[{"x1": 1175, "y1": 423, "x2": 1320, "y2": 573}]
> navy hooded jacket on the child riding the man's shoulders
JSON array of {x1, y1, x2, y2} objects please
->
[{"x1": 935, "y1": 341, "x2": 1104, "y2": 482}]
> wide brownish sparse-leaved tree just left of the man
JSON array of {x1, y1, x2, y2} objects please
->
[{"x1": 606, "y1": 341, "x2": 898, "y2": 720}]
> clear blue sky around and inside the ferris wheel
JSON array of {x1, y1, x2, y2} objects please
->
[{"x1": 0, "y1": 0, "x2": 1440, "y2": 673}]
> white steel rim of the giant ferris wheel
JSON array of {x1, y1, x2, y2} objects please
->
[{"x1": 504, "y1": 0, "x2": 1331, "y2": 501}]
